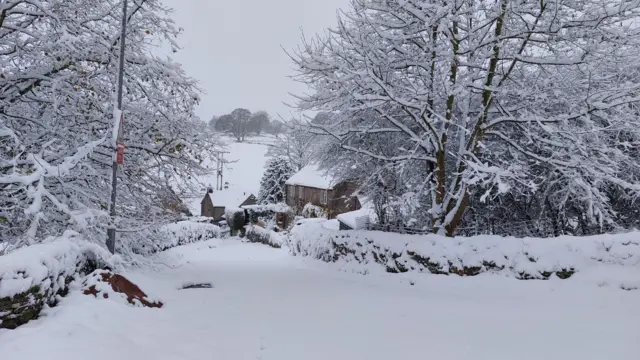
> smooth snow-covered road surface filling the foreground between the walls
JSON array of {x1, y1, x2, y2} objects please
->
[{"x1": 0, "y1": 240, "x2": 640, "y2": 360}]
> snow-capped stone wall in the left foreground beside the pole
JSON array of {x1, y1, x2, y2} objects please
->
[{"x1": 0, "y1": 236, "x2": 111, "y2": 329}]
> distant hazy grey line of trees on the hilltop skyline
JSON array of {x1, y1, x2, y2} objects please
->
[{"x1": 209, "y1": 108, "x2": 284, "y2": 141}]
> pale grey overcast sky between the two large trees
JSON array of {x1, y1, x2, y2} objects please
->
[{"x1": 164, "y1": 0, "x2": 349, "y2": 121}]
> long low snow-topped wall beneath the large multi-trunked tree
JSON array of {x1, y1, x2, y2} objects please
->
[{"x1": 287, "y1": 222, "x2": 640, "y2": 280}]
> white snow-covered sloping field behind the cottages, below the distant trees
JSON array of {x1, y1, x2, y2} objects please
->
[{"x1": 188, "y1": 136, "x2": 273, "y2": 215}]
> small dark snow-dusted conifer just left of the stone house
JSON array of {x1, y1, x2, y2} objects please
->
[{"x1": 258, "y1": 157, "x2": 294, "y2": 204}]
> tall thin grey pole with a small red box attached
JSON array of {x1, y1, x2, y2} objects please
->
[{"x1": 107, "y1": 0, "x2": 129, "y2": 254}]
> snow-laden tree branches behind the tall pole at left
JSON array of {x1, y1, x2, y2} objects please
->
[{"x1": 0, "y1": 0, "x2": 216, "y2": 250}]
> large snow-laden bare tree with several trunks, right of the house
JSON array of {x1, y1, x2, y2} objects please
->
[{"x1": 292, "y1": 0, "x2": 640, "y2": 236}]
